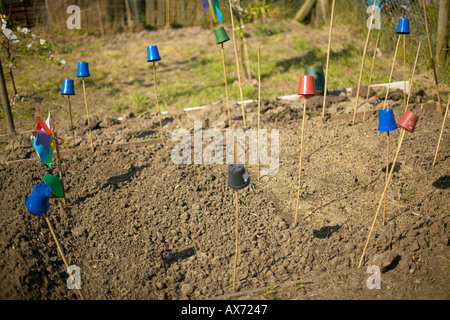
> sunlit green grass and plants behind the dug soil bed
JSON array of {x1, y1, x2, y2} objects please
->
[{"x1": 0, "y1": 0, "x2": 450, "y2": 130}]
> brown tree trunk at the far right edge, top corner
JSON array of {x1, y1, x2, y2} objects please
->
[{"x1": 436, "y1": 0, "x2": 450, "y2": 75}]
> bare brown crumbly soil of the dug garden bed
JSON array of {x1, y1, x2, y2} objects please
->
[{"x1": 0, "y1": 86, "x2": 450, "y2": 300}]
